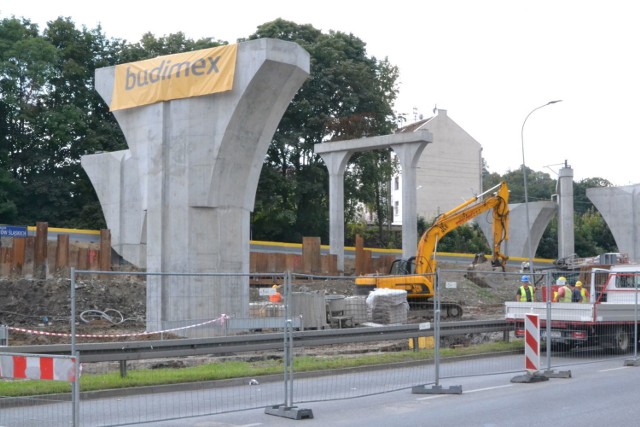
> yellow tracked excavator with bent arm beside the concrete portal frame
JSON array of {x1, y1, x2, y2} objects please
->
[{"x1": 356, "y1": 181, "x2": 509, "y2": 318}]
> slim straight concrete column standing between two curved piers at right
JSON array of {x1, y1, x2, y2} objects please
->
[{"x1": 556, "y1": 162, "x2": 575, "y2": 258}]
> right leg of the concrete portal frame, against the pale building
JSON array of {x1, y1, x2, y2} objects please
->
[{"x1": 391, "y1": 142, "x2": 427, "y2": 259}]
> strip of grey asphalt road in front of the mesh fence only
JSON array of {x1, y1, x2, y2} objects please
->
[{"x1": 146, "y1": 359, "x2": 640, "y2": 427}]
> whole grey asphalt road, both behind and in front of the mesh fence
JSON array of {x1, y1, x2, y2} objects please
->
[{"x1": 0, "y1": 354, "x2": 640, "y2": 427}]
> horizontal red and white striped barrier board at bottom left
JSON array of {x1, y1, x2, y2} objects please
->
[{"x1": 0, "y1": 353, "x2": 76, "y2": 382}]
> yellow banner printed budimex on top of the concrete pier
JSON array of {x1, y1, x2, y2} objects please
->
[{"x1": 109, "y1": 44, "x2": 238, "y2": 111}]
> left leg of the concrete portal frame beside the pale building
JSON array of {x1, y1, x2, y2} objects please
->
[{"x1": 320, "y1": 151, "x2": 353, "y2": 272}]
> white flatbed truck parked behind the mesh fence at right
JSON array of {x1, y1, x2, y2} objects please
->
[{"x1": 505, "y1": 266, "x2": 640, "y2": 371}]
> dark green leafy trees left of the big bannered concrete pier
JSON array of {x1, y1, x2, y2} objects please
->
[{"x1": 0, "y1": 18, "x2": 123, "y2": 228}]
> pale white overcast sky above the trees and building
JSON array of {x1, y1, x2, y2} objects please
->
[{"x1": 5, "y1": 0, "x2": 640, "y2": 186}]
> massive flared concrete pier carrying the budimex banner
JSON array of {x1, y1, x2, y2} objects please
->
[{"x1": 82, "y1": 39, "x2": 309, "y2": 336}]
